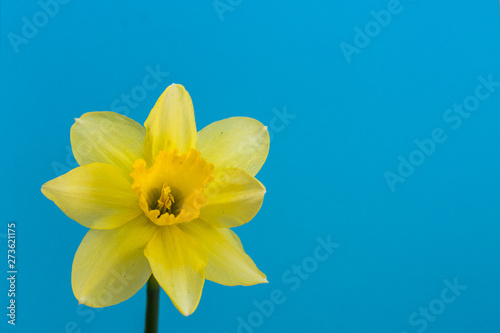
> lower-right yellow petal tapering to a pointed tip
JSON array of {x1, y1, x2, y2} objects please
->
[{"x1": 179, "y1": 220, "x2": 267, "y2": 286}]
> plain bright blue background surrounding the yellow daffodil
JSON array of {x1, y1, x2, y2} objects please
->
[{"x1": 0, "y1": 0, "x2": 500, "y2": 333}]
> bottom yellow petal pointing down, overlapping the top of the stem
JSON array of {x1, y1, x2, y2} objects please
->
[{"x1": 144, "y1": 225, "x2": 207, "y2": 316}]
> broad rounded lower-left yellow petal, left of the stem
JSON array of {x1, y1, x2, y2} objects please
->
[{"x1": 71, "y1": 215, "x2": 157, "y2": 307}]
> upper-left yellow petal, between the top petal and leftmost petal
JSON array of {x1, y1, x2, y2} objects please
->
[{"x1": 71, "y1": 111, "x2": 146, "y2": 178}]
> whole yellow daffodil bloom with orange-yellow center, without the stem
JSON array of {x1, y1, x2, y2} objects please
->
[{"x1": 42, "y1": 84, "x2": 269, "y2": 316}]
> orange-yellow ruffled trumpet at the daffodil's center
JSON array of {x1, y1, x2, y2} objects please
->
[{"x1": 130, "y1": 149, "x2": 214, "y2": 225}]
